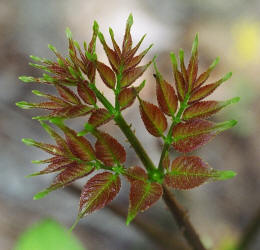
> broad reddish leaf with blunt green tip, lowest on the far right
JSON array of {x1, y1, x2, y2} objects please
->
[{"x1": 164, "y1": 156, "x2": 235, "y2": 189}]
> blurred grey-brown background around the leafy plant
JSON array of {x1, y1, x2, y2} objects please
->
[{"x1": 0, "y1": 0, "x2": 260, "y2": 250}]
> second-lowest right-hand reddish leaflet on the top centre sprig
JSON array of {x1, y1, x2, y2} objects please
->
[{"x1": 121, "y1": 61, "x2": 152, "y2": 88}]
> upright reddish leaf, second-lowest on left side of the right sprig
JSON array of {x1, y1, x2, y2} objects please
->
[{"x1": 156, "y1": 74, "x2": 178, "y2": 117}]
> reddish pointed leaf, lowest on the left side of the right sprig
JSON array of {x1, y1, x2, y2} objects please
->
[{"x1": 140, "y1": 100, "x2": 167, "y2": 137}]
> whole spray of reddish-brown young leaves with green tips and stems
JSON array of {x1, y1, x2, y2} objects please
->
[{"x1": 17, "y1": 15, "x2": 239, "y2": 249}]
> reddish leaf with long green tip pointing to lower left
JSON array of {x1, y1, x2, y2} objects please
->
[{"x1": 33, "y1": 163, "x2": 94, "y2": 200}]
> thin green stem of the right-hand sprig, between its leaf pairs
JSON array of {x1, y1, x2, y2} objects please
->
[{"x1": 158, "y1": 94, "x2": 190, "y2": 173}]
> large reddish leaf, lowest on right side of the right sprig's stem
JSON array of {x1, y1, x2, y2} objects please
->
[{"x1": 172, "y1": 119, "x2": 237, "y2": 153}]
